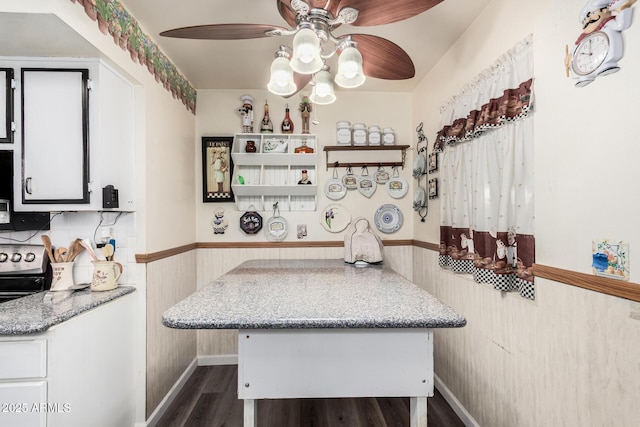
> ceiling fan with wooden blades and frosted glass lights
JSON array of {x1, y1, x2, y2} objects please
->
[{"x1": 160, "y1": 0, "x2": 442, "y2": 103}]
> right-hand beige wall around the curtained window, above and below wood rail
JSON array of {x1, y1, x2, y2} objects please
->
[{"x1": 414, "y1": 0, "x2": 640, "y2": 427}]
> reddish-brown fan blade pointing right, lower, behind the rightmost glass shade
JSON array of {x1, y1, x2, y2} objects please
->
[{"x1": 351, "y1": 34, "x2": 416, "y2": 80}]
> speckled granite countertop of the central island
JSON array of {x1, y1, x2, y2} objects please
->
[{"x1": 162, "y1": 260, "x2": 466, "y2": 329}]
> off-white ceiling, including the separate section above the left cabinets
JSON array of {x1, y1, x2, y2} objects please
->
[{"x1": 0, "y1": 0, "x2": 491, "y2": 92}]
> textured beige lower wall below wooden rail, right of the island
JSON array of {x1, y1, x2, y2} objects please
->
[{"x1": 413, "y1": 248, "x2": 640, "y2": 427}]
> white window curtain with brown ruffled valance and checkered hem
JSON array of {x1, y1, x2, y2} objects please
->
[{"x1": 434, "y1": 36, "x2": 535, "y2": 299}]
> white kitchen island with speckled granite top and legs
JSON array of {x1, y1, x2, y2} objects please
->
[{"x1": 163, "y1": 260, "x2": 466, "y2": 427}]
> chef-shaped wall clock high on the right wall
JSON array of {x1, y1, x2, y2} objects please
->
[{"x1": 565, "y1": 0, "x2": 637, "y2": 87}]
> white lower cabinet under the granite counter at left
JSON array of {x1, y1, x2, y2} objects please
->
[{"x1": 0, "y1": 294, "x2": 135, "y2": 427}]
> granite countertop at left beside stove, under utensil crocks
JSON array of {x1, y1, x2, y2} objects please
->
[{"x1": 0, "y1": 286, "x2": 135, "y2": 336}]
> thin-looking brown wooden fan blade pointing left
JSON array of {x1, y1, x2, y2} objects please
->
[{"x1": 160, "y1": 24, "x2": 287, "y2": 40}]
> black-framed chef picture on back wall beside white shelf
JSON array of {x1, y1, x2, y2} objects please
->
[{"x1": 202, "y1": 136, "x2": 234, "y2": 203}]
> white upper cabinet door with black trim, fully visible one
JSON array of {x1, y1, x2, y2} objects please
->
[{"x1": 21, "y1": 68, "x2": 89, "y2": 204}]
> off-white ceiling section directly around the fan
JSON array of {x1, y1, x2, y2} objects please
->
[{"x1": 120, "y1": 0, "x2": 491, "y2": 92}]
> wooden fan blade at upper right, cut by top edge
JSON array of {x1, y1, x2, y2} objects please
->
[{"x1": 332, "y1": 0, "x2": 443, "y2": 27}]
